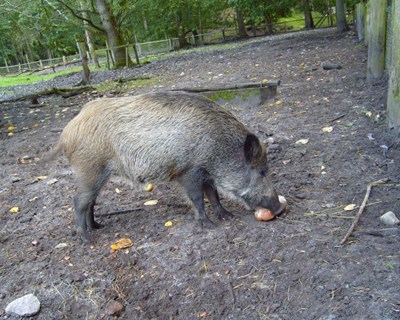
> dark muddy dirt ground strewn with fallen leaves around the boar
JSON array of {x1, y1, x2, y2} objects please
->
[{"x1": 0, "y1": 30, "x2": 400, "y2": 320}]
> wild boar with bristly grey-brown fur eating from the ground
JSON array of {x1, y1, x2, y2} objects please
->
[{"x1": 48, "y1": 92, "x2": 284, "y2": 241}]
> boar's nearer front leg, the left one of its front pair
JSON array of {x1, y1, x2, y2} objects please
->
[{"x1": 178, "y1": 168, "x2": 214, "y2": 227}]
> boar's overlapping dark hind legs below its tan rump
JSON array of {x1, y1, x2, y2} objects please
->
[{"x1": 74, "y1": 166, "x2": 112, "y2": 242}]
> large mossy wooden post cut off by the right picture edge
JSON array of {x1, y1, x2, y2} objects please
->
[{"x1": 387, "y1": 1, "x2": 400, "y2": 141}]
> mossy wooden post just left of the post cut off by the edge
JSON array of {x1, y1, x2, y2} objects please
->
[{"x1": 367, "y1": 0, "x2": 386, "y2": 84}]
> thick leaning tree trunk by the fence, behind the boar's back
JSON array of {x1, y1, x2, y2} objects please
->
[{"x1": 96, "y1": 0, "x2": 132, "y2": 68}]
